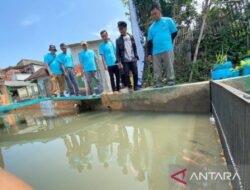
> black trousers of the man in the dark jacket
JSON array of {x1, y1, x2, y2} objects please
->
[{"x1": 122, "y1": 61, "x2": 138, "y2": 88}]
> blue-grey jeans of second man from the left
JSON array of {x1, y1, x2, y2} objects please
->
[{"x1": 65, "y1": 68, "x2": 79, "y2": 95}]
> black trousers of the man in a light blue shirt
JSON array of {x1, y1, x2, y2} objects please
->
[{"x1": 108, "y1": 65, "x2": 120, "y2": 92}]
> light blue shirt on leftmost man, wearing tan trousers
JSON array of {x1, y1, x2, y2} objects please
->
[{"x1": 44, "y1": 53, "x2": 63, "y2": 75}]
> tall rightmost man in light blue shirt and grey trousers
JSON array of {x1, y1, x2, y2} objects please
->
[{"x1": 147, "y1": 3, "x2": 177, "y2": 88}]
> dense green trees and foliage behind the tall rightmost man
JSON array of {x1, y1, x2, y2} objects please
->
[{"x1": 121, "y1": 0, "x2": 250, "y2": 83}]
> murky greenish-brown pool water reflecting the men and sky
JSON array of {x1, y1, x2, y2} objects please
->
[{"x1": 0, "y1": 112, "x2": 231, "y2": 190}]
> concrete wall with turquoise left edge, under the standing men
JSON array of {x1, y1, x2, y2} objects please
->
[{"x1": 0, "y1": 76, "x2": 250, "y2": 113}]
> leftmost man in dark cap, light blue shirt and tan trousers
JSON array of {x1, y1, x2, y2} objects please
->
[{"x1": 44, "y1": 45, "x2": 65, "y2": 97}]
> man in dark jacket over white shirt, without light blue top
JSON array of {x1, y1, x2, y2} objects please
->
[{"x1": 116, "y1": 21, "x2": 139, "y2": 90}]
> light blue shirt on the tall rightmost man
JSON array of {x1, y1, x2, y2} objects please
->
[{"x1": 148, "y1": 17, "x2": 177, "y2": 55}]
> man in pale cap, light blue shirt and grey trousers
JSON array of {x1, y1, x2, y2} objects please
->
[{"x1": 79, "y1": 42, "x2": 103, "y2": 95}]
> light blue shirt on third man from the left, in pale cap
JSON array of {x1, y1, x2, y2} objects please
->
[{"x1": 79, "y1": 49, "x2": 96, "y2": 72}]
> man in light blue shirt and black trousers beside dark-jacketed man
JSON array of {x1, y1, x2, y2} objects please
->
[{"x1": 99, "y1": 30, "x2": 120, "y2": 92}]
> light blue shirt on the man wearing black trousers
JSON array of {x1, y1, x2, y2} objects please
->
[{"x1": 99, "y1": 41, "x2": 116, "y2": 67}]
